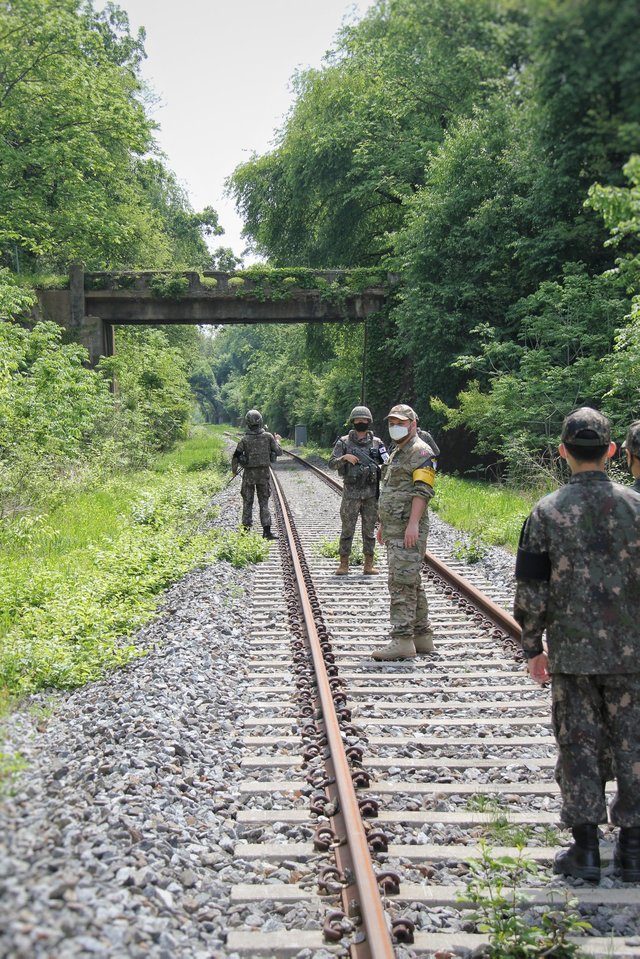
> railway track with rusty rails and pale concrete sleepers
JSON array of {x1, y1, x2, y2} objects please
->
[{"x1": 228, "y1": 459, "x2": 640, "y2": 959}]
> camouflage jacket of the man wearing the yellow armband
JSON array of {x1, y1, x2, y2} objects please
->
[{"x1": 378, "y1": 436, "x2": 435, "y2": 536}]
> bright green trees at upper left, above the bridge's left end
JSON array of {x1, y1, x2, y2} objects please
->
[{"x1": 0, "y1": 0, "x2": 220, "y2": 271}]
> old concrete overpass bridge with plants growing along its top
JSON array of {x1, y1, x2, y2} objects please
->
[{"x1": 38, "y1": 265, "x2": 394, "y2": 364}]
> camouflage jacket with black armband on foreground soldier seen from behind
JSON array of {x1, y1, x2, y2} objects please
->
[{"x1": 514, "y1": 470, "x2": 640, "y2": 674}]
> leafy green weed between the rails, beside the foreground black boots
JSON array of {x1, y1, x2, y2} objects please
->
[{"x1": 458, "y1": 842, "x2": 590, "y2": 959}]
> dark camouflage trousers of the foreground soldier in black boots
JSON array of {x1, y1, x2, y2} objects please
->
[{"x1": 551, "y1": 673, "x2": 640, "y2": 826}]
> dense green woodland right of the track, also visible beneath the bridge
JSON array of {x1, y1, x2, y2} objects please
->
[{"x1": 224, "y1": 0, "x2": 640, "y2": 470}]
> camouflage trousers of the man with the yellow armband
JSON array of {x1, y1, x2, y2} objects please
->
[{"x1": 383, "y1": 527, "x2": 429, "y2": 639}]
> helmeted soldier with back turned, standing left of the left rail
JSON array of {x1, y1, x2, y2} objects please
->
[{"x1": 231, "y1": 410, "x2": 282, "y2": 539}]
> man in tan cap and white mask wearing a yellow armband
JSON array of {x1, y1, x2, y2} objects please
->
[{"x1": 372, "y1": 404, "x2": 436, "y2": 661}]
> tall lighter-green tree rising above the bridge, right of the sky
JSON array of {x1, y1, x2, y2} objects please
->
[{"x1": 229, "y1": 0, "x2": 518, "y2": 267}]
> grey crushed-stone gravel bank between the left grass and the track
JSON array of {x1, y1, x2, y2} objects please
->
[{"x1": 0, "y1": 466, "x2": 524, "y2": 959}]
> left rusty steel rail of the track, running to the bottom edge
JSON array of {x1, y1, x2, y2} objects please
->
[{"x1": 271, "y1": 470, "x2": 395, "y2": 959}]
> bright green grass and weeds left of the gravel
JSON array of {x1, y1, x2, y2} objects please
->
[{"x1": 0, "y1": 426, "x2": 266, "y2": 712}]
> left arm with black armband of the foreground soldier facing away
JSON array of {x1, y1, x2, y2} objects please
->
[{"x1": 513, "y1": 510, "x2": 551, "y2": 660}]
